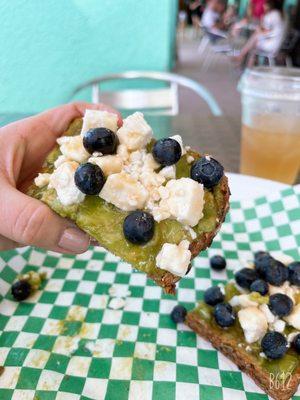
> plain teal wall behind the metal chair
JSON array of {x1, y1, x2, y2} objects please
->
[{"x1": 0, "y1": 0, "x2": 177, "y2": 113}]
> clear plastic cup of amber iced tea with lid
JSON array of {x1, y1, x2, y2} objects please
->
[{"x1": 239, "y1": 67, "x2": 300, "y2": 184}]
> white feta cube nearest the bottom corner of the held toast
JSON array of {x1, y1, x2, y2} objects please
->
[{"x1": 156, "y1": 240, "x2": 192, "y2": 276}]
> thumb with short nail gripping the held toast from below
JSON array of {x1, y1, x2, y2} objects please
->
[{"x1": 0, "y1": 185, "x2": 89, "y2": 253}]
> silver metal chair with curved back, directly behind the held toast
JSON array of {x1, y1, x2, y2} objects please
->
[{"x1": 71, "y1": 71, "x2": 223, "y2": 116}]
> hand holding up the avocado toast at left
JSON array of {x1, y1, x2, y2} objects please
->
[{"x1": 0, "y1": 103, "x2": 122, "y2": 254}]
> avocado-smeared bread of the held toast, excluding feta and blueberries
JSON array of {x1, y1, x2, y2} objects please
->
[{"x1": 28, "y1": 118, "x2": 230, "y2": 293}]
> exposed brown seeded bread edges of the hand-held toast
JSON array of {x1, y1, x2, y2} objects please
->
[{"x1": 27, "y1": 118, "x2": 230, "y2": 294}]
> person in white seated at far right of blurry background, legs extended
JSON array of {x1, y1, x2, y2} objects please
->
[{"x1": 233, "y1": 0, "x2": 286, "y2": 66}]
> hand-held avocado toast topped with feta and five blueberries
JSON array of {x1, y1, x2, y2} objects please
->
[{"x1": 28, "y1": 110, "x2": 230, "y2": 293}]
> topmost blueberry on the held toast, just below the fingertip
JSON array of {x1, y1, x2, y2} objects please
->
[{"x1": 83, "y1": 128, "x2": 118, "y2": 154}]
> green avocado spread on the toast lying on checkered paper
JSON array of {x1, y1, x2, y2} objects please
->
[{"x1": 192, "y1": 283, "x2": 300, "y2": 380}]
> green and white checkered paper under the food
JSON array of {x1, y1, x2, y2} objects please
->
[{"x1": 0, "y1": 187, "x2": 300, "y2": 400}]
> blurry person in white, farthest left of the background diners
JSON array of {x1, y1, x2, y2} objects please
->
[{"x1": 201, "y1": 0, "x2": 226, "y2": 39}]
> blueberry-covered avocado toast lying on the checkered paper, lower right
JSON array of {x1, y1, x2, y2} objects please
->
[{"x1": 185, "y1": 252, "x2": 300, "y2": 400}]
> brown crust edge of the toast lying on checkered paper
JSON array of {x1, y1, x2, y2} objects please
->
[{"x1": 185, "y1": 311, "x2": 300, "y2": 400}]
